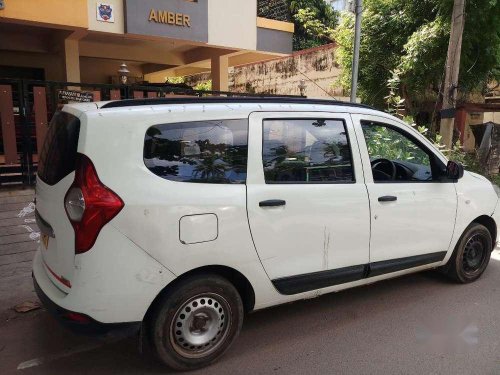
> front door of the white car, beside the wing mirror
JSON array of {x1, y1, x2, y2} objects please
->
[{"x1": 352, "y1": 115, "x2": 457, "y2": 270}]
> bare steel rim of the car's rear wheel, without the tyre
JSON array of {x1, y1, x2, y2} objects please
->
[{"x1": 169, "y1": 293, "x2": 231, "y2": 358}]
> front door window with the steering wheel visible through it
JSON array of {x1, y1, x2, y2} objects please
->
[{"x1": 361, "y1": 121, "x2": 432, "y2": 182}]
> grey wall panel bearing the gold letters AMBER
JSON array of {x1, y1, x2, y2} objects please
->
[{"x1": 125, "y1": 0, "x2": 208, "y2": 42}]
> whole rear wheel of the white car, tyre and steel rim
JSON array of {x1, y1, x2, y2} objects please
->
[{"x1": 148, "y1": 274, "x2": 244, "y2": 371}]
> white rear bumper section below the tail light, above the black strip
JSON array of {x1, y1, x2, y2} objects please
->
[{"x1": 33, "y1": 225, "x2": 175, "y2": 324}]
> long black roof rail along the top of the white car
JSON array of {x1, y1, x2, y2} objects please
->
[{"x1": 101, "y1": 96, "x2": 374, "y2": 109}]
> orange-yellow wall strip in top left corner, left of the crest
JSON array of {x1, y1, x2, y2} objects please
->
[{"x1": 0, "y1": 0, "x2": 88, "y2": 28}]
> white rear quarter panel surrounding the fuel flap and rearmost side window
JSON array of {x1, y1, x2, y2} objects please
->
[{"x1": 79, "y1": 106, "x2": 277, "y2": 308}]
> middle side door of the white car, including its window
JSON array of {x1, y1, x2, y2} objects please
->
[{"x1": 247, "y1": 112, "x2": 370, "y2": 294}]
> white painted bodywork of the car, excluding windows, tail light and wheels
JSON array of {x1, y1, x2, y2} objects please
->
[{"x1": 33, "y1": 100, "x2": 500, "y2": 323}]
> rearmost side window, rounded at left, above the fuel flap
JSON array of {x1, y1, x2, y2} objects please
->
[{"x1": 144, "y1": 119, "x2": 248, "y2": 184}]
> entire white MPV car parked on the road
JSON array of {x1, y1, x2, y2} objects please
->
[{"x1": 33, "y1": 98, "x2": 500, "y2": 370}]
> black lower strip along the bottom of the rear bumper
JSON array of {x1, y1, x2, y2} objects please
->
[{"x1": 33, "y1": 276, "x2": 141, "y2": 336}]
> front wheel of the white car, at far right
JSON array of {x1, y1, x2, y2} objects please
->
[{"x1": 444, "y1": 223, "x2": 493, "y2": 284}]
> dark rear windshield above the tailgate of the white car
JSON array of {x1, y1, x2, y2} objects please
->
[{"x1": 38, "y1": 112, "x2": 80, "y2": 185}]
